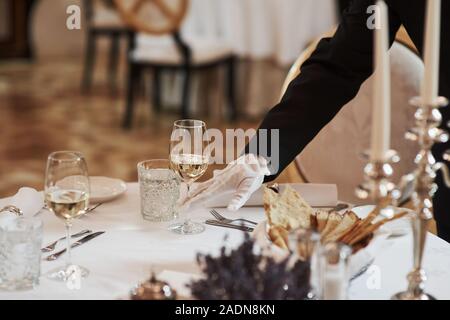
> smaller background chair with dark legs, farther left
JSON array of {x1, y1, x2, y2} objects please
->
[{"x1": 81, "y1": 0, "x2": 134, "y2": 94}]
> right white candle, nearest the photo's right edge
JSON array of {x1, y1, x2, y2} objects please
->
[{"x1": 422, "y1": 0, "x2": 441, "y2": 105}]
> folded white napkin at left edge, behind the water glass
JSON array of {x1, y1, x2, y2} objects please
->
[{"x1": 0, "y1": 188, "x2": 44, "y2": 223}]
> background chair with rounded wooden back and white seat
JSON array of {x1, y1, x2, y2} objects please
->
[{"x1": 115, "y1": 0, "x2": 237, "y2": 128}]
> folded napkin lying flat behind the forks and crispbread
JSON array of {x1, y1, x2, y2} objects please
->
[{"x1": 204, "y1": 183, "x2": 338, "y2": 208}]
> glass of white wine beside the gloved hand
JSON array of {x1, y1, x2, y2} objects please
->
[{"x1": 169, "y1": 120, "x2": 209, "y2": 235}]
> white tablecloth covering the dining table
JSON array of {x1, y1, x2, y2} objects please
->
[{"x1": 0, "y1": 184, "x2": 450, "y2": 299}]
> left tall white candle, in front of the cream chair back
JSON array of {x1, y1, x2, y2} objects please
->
[{"x1": 371, "y1": 0, "x2": 391, "y2": 161}]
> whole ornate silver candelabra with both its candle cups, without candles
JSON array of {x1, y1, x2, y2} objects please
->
[{"x1": 356, "y1": 97, "x2": 450, "y2": 300}]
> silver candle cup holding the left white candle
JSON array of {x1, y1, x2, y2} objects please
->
[{"x1": 356, "y1": 150, "x2": 400, "y2": 217}]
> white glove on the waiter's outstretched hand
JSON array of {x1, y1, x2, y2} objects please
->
[{"x1": 182, "y1": 154, "x2": 270, "y2": 211}]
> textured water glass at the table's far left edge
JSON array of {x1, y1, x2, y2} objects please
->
[{"x1": 0, "y1": 217, "x2": 43, "y2": 291}]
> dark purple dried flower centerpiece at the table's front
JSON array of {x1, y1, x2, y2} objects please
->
[{"x1": 188, "y1": 235, "x2": 310, "y2": 300}]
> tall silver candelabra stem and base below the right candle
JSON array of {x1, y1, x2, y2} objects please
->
[{"x1": 392, "y1": 97, "x2": 450, "y2": 300}]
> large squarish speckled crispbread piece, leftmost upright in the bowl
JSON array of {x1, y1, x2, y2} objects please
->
[{"x1": 264, "y1": 186, "x2": 314, "y2": 231}]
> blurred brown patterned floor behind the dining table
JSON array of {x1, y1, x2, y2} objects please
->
[{"x1": 0, "y1": 60, "x2": 285, "y2": 197}]
